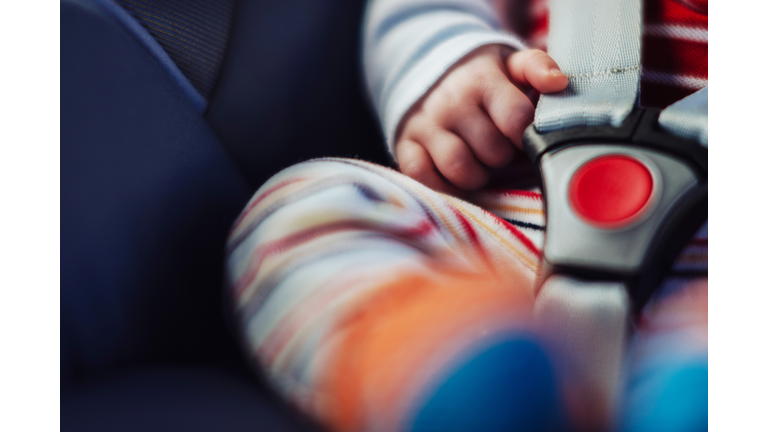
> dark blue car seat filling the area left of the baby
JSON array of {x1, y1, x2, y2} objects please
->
[{"x1": 60, "y1": 0, "x2": 388, "y2": 431}]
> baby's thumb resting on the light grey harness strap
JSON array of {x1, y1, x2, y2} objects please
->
[{"x1": 507, "y1": 50, "x2": 568, "y2": 93}]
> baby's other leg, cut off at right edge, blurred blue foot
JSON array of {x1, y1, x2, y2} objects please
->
[{"x1": 622, "y1": 225, "x2": 708, "y2": 432}]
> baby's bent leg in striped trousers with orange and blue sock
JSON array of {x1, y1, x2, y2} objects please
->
[{"x1": 227, "y1": 159, "x2": 561, "y2": 430}]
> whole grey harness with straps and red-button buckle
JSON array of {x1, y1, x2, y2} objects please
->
[{"x1": 523, "y1": 0, "x2": 707, "y2": 429}]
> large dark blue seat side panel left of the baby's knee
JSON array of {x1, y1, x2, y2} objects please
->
[{"x1": 61, "y1": 1, "x2": 253, "y2": 383}]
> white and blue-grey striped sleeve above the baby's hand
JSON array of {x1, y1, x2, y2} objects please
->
[{"x1": 363, "y1": 0, "x2": 525, "y2": 158}]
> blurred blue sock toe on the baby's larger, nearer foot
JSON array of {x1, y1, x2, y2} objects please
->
[{"x1": 412, "y1": 336, "x2": 567, "y2": 432}]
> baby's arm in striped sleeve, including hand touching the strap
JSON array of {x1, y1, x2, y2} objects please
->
[{"x1": 363, "y1": 0, "x2": 567, "y2": 193}]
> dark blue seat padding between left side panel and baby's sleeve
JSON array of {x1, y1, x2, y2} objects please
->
[{"x1": 205, "y1": 0, "x2": 389, "y2": 186}]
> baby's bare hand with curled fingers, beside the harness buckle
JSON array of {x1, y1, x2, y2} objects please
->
[{"x1": 395, "y1": 45, "x2": 568, "y2": 194}]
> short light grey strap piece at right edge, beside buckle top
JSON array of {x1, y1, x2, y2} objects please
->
[{"x1": 659, "y1": 87, "x2": 709, "y2": 147}]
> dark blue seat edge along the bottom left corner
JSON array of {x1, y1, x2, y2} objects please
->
[{"x1": 61, "y1": 366, "x2": 319, "y2": 432}]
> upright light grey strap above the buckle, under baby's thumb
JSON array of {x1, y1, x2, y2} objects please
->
[{"x1": 534, "y1": 0, "x2": 642, "y2": 133}]
